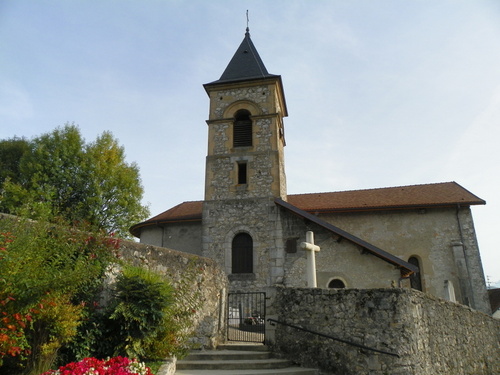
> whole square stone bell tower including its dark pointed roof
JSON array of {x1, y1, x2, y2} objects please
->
[{"x1": 203, "y1": 28, "x2": 287, "y2": 288}]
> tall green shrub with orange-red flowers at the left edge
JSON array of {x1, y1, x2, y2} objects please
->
[{"x1": 0, "y1": 216, "x2": 116, "y2": 374}]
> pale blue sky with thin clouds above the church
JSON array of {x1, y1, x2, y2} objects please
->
[{"x1": 0, "y1": 0, "x2": 500, "y2": 287}]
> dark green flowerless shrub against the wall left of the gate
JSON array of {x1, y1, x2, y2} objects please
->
[{"x1": 63, "y1": 265, "x2": 200, "y2": 362}]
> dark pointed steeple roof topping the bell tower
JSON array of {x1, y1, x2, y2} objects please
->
[{"x1": 206, "y1": 27, "x2": 279, "y2": 83}]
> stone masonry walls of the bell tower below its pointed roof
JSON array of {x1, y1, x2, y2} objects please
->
[{"x1": 202, "y1": 78, "x2": 286, "y2": 291}]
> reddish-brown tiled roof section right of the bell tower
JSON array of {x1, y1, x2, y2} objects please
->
[{"x1": 287, "y1": 182, "x2": 486, "y2": 212}]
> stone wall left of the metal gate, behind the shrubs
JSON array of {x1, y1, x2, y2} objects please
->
[{"x1": 120, "y1": 241, "x2": 227, "y2": 349}]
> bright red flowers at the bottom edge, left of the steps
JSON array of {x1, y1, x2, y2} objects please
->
[{"x1": 42, "y1": 357, "x2": 153, "y2": 375}]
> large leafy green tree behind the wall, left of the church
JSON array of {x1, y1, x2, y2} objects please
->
[{"x1": 0, "y1": 124, "x2": 149, "y2": 236}]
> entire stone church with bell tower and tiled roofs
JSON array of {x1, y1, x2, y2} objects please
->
[{"x1": 130, "y1": 29, "x2": 491, "y2": 314}]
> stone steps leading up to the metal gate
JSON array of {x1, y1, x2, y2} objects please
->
[{"x1": 175, "y1": 344, "x2": 318, "y2": 375}]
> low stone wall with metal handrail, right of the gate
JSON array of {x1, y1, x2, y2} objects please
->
[{"x1": 272, "y1": 288, "x2": 500, "y2": 375}]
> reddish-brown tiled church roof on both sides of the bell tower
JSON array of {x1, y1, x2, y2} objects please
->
[{"x1": 130, "y1": 182, "x2": 486, "y2": 236}]
